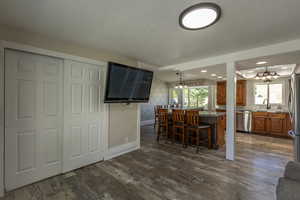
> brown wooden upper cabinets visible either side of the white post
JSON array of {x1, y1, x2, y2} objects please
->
[{"x1": 217, "y1": 80, "x2": 247, "y2": 106}]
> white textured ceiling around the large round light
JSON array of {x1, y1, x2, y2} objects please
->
[{"x1": 0, "y1": 0, "x2": 300, "y2": 65}]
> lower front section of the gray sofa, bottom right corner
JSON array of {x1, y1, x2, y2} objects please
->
[{"x1": 276, "y1": 178, "x2": 300, "y2": 200}]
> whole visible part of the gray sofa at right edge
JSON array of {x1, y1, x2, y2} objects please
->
[{"x1": 276, "y1": 161, "x2": 300, "y2": 200}]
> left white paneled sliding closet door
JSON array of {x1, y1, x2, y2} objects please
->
[{"x1": 5, "y1": 50, "x2": 63, "y2": 190}]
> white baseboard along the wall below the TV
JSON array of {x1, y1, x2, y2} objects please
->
[{"x1": 104, "y1": 141, "x2": 140, "y2": 160}]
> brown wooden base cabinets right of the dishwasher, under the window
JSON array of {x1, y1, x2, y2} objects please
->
[{"x1": 252, "y1": 112, "x2": 292, "y2": 137}]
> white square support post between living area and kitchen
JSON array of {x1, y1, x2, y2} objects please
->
[{"x1": 226, "y1": 62, "x2": 236, "y2": 160}]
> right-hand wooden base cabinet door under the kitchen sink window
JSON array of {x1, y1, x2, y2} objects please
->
[{"x1": 268, "y1": 114, "x2": 286, "y2": 136}]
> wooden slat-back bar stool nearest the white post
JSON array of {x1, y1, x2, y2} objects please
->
[{"x1": 186, "y1": 110, "x2": 211, "y2": 153}]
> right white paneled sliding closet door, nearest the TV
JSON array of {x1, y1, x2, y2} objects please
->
[{"x1": 63, "y1": 60, "x2": 103, "y2": 172}]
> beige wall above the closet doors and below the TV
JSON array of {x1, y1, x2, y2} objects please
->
[{"x1": 0, "y1": 25, "x2": 140, "y2": 196}]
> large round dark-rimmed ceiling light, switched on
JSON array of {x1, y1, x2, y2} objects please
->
[{"x1": 179, "y1": 3, "x2": 221, "y2": 30}]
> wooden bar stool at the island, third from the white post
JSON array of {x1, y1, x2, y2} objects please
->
[{"x1": 156, "y1": 108, "x2": 169, "y2": 142}]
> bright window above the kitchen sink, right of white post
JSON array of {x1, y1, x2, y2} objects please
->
[{"x1": 254, "y1": 83, "x2": 283, "y2": 105}]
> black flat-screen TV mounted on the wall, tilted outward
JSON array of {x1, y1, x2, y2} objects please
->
[{"x1": 104, "y1": 62, "x2": 153, "y2": 103}]
